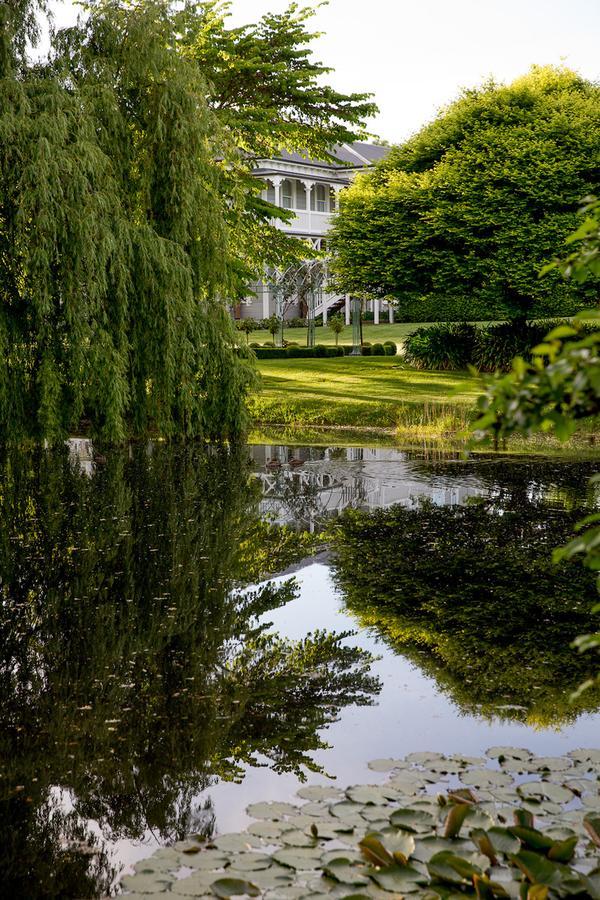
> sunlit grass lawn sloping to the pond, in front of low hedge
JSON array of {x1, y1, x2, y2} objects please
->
[{"x1": 250, "y1": 356, "x2": 481, "y2": 433}]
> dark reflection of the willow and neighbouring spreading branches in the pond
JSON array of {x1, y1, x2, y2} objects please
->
[{"x1": 0, "y1": 447, "x2": 379, "y2": 898}]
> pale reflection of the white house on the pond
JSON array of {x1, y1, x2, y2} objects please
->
[{"x1": 250, "y1": 445, "x2": 486, "y2": 530}]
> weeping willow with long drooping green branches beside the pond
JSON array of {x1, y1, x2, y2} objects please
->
[{"x1": 0, "y1": 3, "x2": 252, "y2": 442}]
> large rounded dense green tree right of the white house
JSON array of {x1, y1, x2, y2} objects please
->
[{"x1": 332, "y1": 67, "x2": 600, "y2": 321}]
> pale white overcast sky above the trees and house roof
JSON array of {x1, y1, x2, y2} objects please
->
[{"x1": 50, "y1": 0, "x2": 600, "y2": 142}]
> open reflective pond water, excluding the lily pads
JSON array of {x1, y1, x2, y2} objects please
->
[{"x1": 0, "y1": 441, "x2": 600, "y2": 898}]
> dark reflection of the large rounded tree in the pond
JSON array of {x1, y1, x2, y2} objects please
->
[{"x1": 334, "y1": 483, "x2": 600, "y2": 727}]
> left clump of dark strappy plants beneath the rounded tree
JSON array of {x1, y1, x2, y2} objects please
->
[{"x1": 404, "y1": 322, "x2": 476, "y2": 369}]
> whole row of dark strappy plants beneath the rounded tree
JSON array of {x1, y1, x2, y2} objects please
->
[{"x1": 404, "y1": 320, "x2": 591, "y2": 372}]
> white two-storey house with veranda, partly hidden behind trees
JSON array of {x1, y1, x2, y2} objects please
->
[{"x1": 236, "y1": 142, "x2": 393, "y2": 324}]
